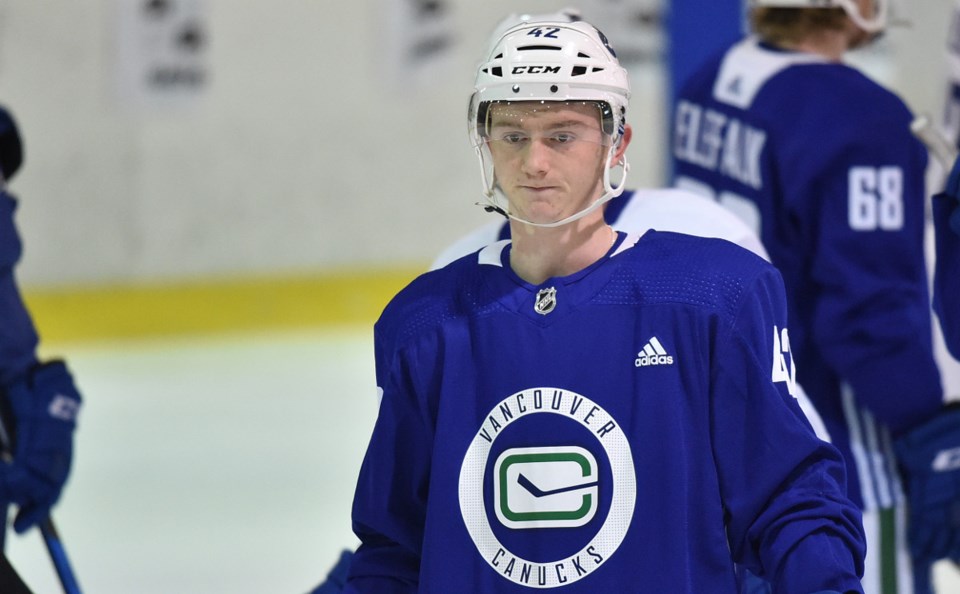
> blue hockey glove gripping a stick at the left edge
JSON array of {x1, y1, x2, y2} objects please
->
[{"x1": 0, "y1": 361, "x2": 81, "y2": 534}]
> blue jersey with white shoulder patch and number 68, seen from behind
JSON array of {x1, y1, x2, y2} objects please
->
[{"x1": 672, "y1": 38, "x2": 943, "y2": 509}]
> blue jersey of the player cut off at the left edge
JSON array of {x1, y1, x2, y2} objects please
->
[{"x1": 0, "y1": 190, "x2": 38, "y2": 388}]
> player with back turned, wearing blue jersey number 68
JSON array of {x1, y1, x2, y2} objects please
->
[{"x1": 672, "y1": 0, "x2": 960, "y2": 593}]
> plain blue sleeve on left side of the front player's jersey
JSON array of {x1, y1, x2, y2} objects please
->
[{"x1": 344, "y1": 322, "x2": 433, "y2": 594}]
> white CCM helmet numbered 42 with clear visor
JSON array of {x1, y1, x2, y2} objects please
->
[{"x1": 468, "y1": 17, "x2": 630, "y2": 227}]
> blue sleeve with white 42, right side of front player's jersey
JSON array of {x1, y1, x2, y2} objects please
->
[{"x1": 712, "y1": 268, "x2": 865, "y2": 594}]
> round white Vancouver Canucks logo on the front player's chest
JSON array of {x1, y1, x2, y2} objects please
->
[{"x1": 459, "y1": 388, "x2": 637, "y2": 588}]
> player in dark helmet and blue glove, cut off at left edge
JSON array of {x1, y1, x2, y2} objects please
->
[{"x1": 0, "y1": 107, "x2": 81, "y2": 547}]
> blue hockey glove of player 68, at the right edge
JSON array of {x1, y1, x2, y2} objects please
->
[{"x1": 894, "y1": 405, "x2": 960, "y2": 570}]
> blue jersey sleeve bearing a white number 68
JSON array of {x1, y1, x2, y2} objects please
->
[{"x1": 783, "y1": 106, "x2": 943, "y2": 434}]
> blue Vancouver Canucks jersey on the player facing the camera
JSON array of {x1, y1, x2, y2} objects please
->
[{"x1": 345, "y1": 231, "x2": 864, "y2": 594}]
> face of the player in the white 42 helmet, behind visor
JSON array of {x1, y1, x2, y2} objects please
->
[{"x1": 486, "y1": 101, "x2": 610, "y2": 223}]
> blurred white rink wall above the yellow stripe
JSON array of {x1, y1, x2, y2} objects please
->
[{"x1": 0, "y1": 0, "x2": 951, "y2": 285}]
